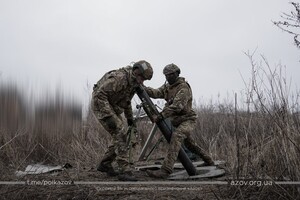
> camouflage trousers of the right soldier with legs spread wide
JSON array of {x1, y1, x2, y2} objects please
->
[{"x1": 162, "y1": 121, "x2": 213, "y2": 173}]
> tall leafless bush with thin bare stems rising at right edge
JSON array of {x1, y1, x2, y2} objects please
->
[{"x1": 226, "y1": 53, "x2": 300, "y2": 198}]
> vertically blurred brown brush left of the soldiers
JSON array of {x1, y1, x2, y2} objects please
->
[{"x1": 0, "y1": 84, "x2": 82, "y2": 168}]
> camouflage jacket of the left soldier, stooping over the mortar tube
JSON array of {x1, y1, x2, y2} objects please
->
[{"x1": 92, "y1": 66, "x2": 135, "y2": 119}]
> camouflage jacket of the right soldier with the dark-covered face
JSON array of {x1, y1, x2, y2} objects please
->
[{"x1": 145, "y1": 77, "x2": 197, "y2": 127}]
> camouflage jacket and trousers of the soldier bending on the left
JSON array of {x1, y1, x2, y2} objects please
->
[{"x1": 91, "y1": 67, "x2": 135, "y2": 172}]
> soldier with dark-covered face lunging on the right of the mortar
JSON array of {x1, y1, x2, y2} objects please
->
[{"x1": 146, "y1": 64, "x2": 214, "y2": 178}]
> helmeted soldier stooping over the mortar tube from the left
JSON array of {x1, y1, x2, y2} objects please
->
[{"x1": 91, "y1": 60, "x2": 153, "y2": 181}]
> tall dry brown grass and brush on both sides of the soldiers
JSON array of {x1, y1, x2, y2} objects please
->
[{"x1": 0, "y1": 54, "x2": 300, "y2": 199}]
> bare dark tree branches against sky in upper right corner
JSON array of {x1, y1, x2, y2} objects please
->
[{"x1": 273, "y1": 2, "x2": 300, "y2": 49}]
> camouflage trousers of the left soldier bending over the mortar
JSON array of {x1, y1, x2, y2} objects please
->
[{"x1": 94, "y1": 110, "x2": 131, "y2": 173}]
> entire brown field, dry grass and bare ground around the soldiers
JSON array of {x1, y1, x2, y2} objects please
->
[{"x1": 0, "y1": 61, "x2": 300, "y2": 199}]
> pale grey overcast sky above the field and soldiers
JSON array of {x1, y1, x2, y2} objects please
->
[{"x1": 0, "y1": 0, "x2": 300, "y2": 109}]
